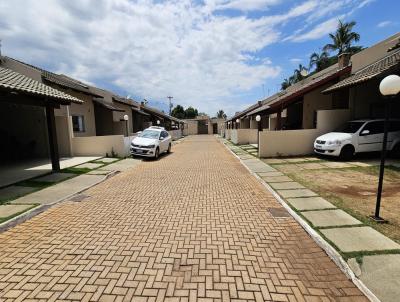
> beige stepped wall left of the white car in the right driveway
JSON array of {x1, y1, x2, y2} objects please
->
[{"x1": 259, "y1": 109, "x2": 350, "y2": 157}]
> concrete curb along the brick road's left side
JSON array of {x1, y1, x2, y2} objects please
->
[{"x1": 0, "y1": 171, "x2": 119, "y2": 233}]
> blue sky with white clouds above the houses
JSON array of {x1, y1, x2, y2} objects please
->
[{"x1": 0, "y1": 0, "x2": 400, "y2": 115}]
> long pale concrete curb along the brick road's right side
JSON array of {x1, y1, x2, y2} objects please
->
[{"x1": 221, "y1": 142, "x2": 380, "y2": 302}]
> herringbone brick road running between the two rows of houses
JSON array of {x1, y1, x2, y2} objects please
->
[{"x1": 0, "y1": 136, "x2": 365, "y2": 301}]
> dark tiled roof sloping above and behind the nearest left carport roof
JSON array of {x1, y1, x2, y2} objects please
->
[{"x1": 5, "y1": 57, "x2": 99, "y2": 96}]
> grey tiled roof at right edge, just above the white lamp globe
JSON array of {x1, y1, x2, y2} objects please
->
[{"x1": 322, "y1": 49, "x2": 400, "y2": 93}]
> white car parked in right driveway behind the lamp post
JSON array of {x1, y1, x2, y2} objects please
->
[{"x1": 314, "y1": 119, "x2": 400, "y2": 160}]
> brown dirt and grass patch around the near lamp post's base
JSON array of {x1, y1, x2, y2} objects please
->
[{"x1": 289, "y1": 167, "x2": 400, "y2": 242}]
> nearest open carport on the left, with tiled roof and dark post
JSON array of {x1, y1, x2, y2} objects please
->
[{"x1": 0, "y1": 67, "x2": 82, "y2": 183}]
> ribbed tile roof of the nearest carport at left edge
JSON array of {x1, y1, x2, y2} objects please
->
[{"x1": 0, "y1": 67, "x2": 83, "y2": 104}]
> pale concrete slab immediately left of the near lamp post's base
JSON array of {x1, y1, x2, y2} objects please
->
[{"x1": 302, "y1": 210, "x2": 362, "y2": 227}]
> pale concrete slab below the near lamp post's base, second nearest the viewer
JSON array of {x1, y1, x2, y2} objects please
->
[{"x1": 321, "y1": 227, "x2": 400, "y2": 253}]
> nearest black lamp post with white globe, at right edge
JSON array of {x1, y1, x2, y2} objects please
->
[{"x1": 371, "y1": 75, "x2": 400, "y2": 223}]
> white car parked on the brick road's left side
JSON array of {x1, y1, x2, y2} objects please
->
[{"x1": 130, "y1": 127, "x2": 172, "y2": 159}]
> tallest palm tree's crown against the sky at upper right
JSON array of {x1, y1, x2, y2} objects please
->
[{"x1": 324, "y1": 20, "x2": 360, "y2": 55}]
